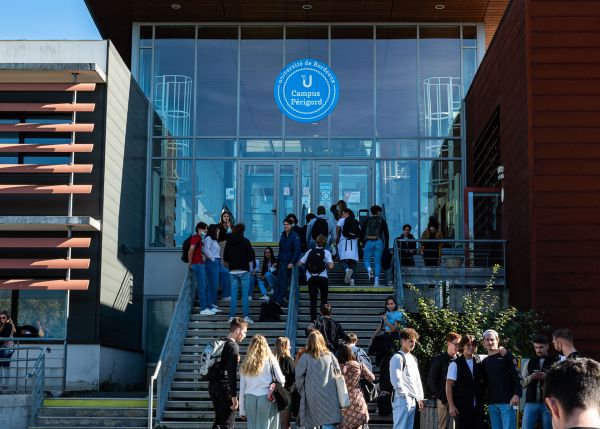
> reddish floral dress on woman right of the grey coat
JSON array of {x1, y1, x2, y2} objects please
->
[{"x1": 338, "y1": 361, "x2": 375, "y2": 429}]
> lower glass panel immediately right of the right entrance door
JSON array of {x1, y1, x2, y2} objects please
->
[{"x1": 376, "y1": 160, "x2": 419, "y2": 238}]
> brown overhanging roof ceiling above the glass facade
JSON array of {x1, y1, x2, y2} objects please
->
[{"x1": 85, "y1": 0, "x2": 510, "y2": 63}]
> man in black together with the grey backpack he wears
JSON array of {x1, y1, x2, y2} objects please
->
[{"x1": 200, "y1": 317, "x2": 248, "y2": 429}]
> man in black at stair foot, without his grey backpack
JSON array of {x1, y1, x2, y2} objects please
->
[{"x1": 208, "y1": 317, "x2": 248, "y2": 429}]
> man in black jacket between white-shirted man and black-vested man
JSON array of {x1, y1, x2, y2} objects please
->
[{"x1": 427, "y1": 332, "x2": 461, "y2": 429}]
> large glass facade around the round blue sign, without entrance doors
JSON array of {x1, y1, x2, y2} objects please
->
[{"x1": 136, "y1": 24, "x2": 479, "y2": 247}]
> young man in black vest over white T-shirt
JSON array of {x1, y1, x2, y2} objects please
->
[{"x1": 446, "y1": 335, "x2": 484, "y2": 429}]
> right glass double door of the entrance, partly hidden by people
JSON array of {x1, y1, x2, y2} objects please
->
[{"x1": 313, "y1": 161, "x2": 373, "y2": 214}]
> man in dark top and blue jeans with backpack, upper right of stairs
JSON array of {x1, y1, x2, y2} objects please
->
[{"x1": 361, "y1": 205, "x2": 390, "y2": 287}]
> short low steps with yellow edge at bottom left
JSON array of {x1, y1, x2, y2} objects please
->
[{"x1": 29, "y1": 398, "x2": 148, "y2": 429}]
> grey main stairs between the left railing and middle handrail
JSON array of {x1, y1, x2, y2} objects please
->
[{"x1": 159, "y1": 294, "x2": 286, "y2": 429}]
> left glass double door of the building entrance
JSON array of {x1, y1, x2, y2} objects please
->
[{"x1": 240, "y1": 162, "x2": 298, "y2": 242}]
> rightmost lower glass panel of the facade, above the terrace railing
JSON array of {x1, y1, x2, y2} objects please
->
[{"x1": 420, "y1": 160, "x2": 462, "y2": 239}]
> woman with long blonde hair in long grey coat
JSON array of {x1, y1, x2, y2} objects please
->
[{"x1": 296, "y1": 331, "x2": 342, "y2": 429}]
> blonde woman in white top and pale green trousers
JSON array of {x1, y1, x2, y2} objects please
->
[{"x1": 239, "y1": 334, "x2": 285, "y2": 429}]
